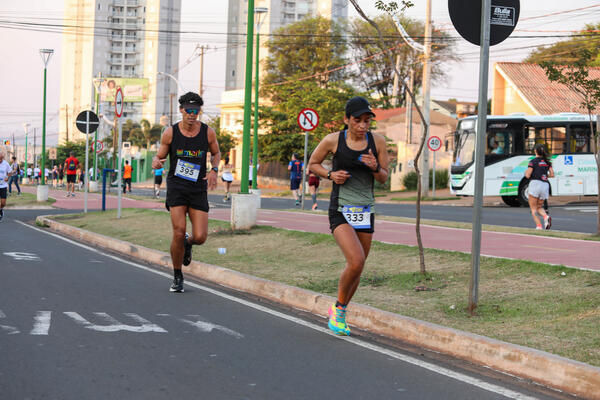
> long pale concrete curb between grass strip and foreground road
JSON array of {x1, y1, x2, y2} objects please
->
[{"x1": 36, "y1": 216, "x2": 600, "y2": 400}]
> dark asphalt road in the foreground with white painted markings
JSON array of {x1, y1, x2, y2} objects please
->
[{"x1": 0, "y1": 210, "x2": 565, "y2": 400}]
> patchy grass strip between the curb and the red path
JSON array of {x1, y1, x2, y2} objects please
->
[{"x1": 54, "y1": 209, "x2": 600, "y2": 366}]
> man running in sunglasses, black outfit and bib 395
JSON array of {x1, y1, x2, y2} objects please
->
[{"x1": 152, "y1": 92, "x2": 221, "y2": 293}]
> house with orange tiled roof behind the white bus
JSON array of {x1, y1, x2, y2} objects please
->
[{"x1": 492, "y1": 62, "x2": 600, "y2": 115}]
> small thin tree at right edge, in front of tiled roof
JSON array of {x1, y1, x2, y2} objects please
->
[{"x1": 541, "y1": 49, "x2": 600, "y2": 235}]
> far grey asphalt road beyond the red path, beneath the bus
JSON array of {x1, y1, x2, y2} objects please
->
[{"x1": 133, "y1": 188, "x2": 598, "y2": 233}]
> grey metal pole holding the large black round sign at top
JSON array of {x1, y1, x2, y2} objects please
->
[{"x1": 469, "y1": 0, "x2": 492, "y2": 314}]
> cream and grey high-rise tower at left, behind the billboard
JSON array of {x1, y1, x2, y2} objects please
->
[{"x1": 59, "y1": 0, "x2": 181, "y2": 143}]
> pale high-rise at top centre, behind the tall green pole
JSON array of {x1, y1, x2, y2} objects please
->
[{"x1": 225, "y1": 0, "x2": 348, "y2": 90}]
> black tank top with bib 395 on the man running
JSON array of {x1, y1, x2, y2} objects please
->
[{"x1": 167, "y1": 122, "x2": 208, "y2": 190}]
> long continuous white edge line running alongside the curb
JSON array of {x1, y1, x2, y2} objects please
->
[{"x1": 21, "y1": 221, "x2": 537, "y2": 400}]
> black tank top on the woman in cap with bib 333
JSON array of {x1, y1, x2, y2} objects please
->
[{"x1": 329, "y1": 131, "x2": 377, "y2": 211}]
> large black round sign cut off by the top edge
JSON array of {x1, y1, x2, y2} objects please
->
[{"x1": 448, "y1": 0, "x2": 521, "y2": 46}]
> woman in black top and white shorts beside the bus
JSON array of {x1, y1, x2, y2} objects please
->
[{"x1": 525, "y1": 143, "x2": 554, "y2": 229}]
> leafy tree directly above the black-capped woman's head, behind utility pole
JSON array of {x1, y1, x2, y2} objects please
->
[{"x1": 350, "y1": 14, "x2": 455, "y2": 108}]
